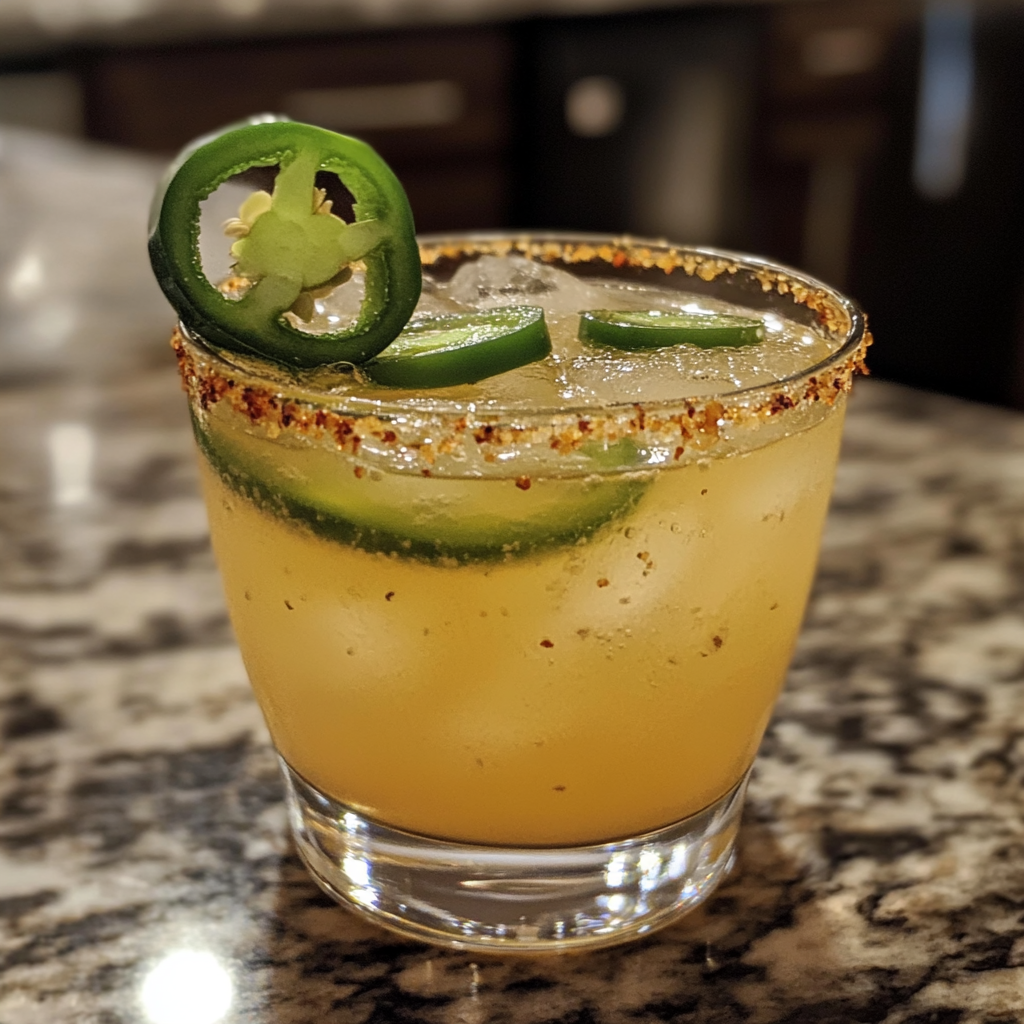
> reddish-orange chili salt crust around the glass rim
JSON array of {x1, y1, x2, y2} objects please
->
[{"x1": 171, "y1": 232, "x2": 872, "y2": 466}]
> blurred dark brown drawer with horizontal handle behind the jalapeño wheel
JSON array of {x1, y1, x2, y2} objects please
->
[{"x1": 80, "y1": 28, "x2": 513, "y2": 231}]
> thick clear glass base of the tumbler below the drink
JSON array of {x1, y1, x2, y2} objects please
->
[{"x1": 282, "y1": 761, "x2": 746, "y2": 953}]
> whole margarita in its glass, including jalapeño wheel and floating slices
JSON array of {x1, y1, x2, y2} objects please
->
[{"x1": 148, "y1": 115, "x2": 870, "y2": 951}]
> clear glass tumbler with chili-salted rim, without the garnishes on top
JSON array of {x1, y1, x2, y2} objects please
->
[{"x1": 174, "y1": 236, "x2": 869, "y2": 951}]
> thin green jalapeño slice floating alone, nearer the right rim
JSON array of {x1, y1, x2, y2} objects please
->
[{"x1": 579, "y1": 309, "x2": 765, "y2": 351}]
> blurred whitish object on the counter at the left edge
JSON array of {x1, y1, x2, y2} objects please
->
[{"x1": 0, "y1": 127, "x2": 174, "y2": 383}]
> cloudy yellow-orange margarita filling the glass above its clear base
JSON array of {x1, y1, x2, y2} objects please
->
[{"x1": 179, "y1": 239, "x2": 850, "y2": 847}]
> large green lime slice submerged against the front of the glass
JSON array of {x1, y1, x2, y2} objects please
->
[{"x1": 195, "y1": 411, "x2": 651, "y2": 564}]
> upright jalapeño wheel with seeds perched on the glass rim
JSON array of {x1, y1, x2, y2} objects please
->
[{"x1": 150, "y1": 119, "x2": 421, "y2": 368}]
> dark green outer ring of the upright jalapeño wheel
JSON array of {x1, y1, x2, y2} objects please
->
[{"x1": 150, "y1": 115, "x2": 422, "y2": 369}]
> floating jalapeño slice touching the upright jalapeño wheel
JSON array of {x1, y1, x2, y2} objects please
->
[{"x1": 362, "y1": 306, "x2": 551, "y2": 388}]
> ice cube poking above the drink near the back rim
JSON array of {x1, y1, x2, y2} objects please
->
[{"x1": 446, "y1": 256, "x2": 604, "y2": 313}]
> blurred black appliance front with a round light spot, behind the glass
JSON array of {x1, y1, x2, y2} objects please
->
[{"x1": 515, "y1": 7, "x2": 763, "y2": 247}]
